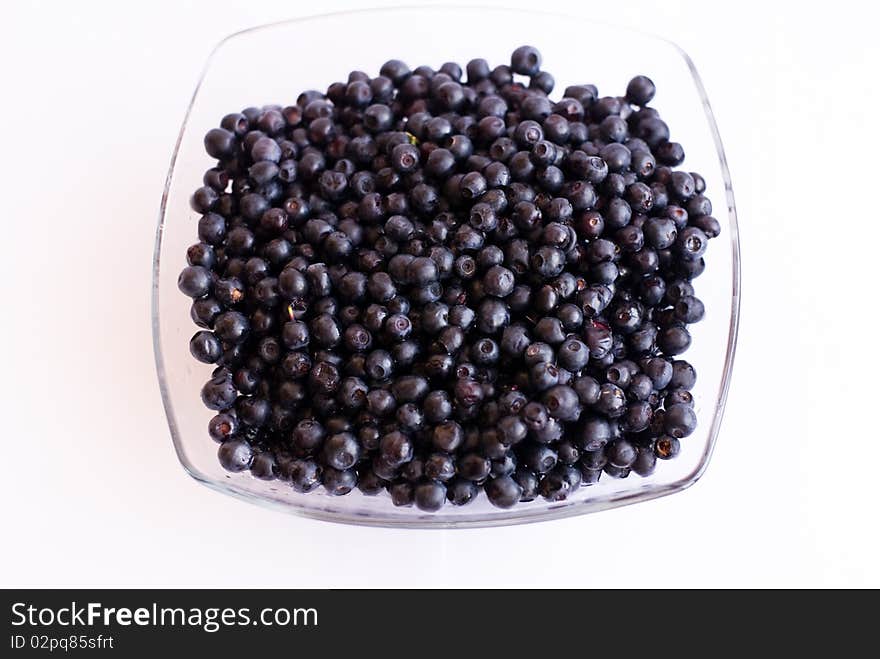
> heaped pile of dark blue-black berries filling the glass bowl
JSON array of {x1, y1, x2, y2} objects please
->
[{"x1": 178, "y1": 46, "x2": 720, "y2": 511}]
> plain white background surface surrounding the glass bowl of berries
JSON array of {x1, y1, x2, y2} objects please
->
[{"x1": 0, "y1": 0, "x2": 880, "y2": 587}]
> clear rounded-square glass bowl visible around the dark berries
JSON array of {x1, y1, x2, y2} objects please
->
[{"x1": 153, "y1": 8, "x2": 740, "y2": 528}]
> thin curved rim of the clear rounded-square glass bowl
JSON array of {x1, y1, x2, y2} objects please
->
[{"x1": 150, "y1": 3, "x2": 742, "y2": 529}]
